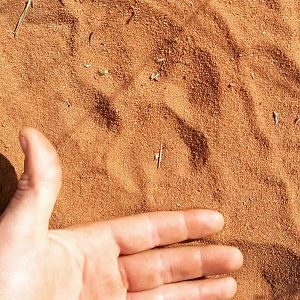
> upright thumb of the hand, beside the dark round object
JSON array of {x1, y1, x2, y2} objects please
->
[{"x1": 1, "y1": 128, "x2": 61, "y2": 238}]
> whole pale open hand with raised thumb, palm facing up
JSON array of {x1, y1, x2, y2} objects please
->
[{"x1": 0, "y1": 128, "x2": 243, "y2": 300}]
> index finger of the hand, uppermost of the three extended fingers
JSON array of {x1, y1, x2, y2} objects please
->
[{"x1": 106, "y1": 210, "x2": 224, "y2": 254}]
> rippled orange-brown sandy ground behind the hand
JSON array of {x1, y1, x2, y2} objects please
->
[{"x1": 0, "y1": 0, "x2": 300, "y2": 300}]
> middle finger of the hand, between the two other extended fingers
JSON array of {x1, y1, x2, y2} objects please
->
[{"x1": 119, "y1": 246, "x2": 243, "y2": 292}]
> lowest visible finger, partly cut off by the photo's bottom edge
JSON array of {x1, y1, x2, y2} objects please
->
[{"x1": 127, "y1": 277, "x2": 237, "y2": 300}]
